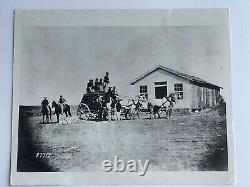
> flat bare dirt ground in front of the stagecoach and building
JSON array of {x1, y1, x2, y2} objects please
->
[{"x1": 18, "y1": 110, "x2": 228, "y2": 171}]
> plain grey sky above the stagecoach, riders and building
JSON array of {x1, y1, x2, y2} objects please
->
[{"x1": 20, "y1": 26, "x2": 229, "y2": 105}]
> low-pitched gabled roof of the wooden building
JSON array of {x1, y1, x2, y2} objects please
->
[{"x1": 130, "y1": 65, "x2": 222, "y2": 88}]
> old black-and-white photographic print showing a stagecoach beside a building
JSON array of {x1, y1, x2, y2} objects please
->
[{"x1": 12, "y1": 9, "x2": 232, "y2": 185}]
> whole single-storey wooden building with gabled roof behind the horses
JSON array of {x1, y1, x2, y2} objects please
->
[{"x1": 130, "y1": 65, "x2": 221, "y2": 109}]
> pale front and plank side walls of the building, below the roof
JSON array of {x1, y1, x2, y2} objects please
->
[{"x1": 132, "y1": 69, "x2": 220, "y2": 109}]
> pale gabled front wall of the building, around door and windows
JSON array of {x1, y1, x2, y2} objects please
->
[{"x1": 132, "y1": 69, "x2": 192, "y2": 108}]
